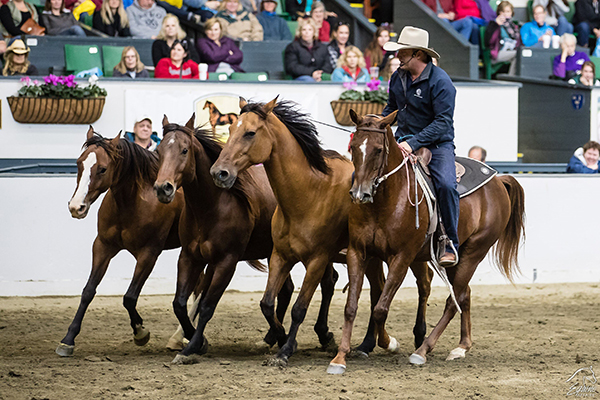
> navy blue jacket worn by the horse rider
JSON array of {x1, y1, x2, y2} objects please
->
[{"x1": 383, "y1": 63, "x2": 456, "y2": 151}]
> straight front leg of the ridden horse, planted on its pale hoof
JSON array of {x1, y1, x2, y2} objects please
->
[{"x1": 327, "y1": 247, "x2": 366, "y2": 374}]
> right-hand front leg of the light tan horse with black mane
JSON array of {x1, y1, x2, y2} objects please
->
[{"x1": 270, "y1": 255, "x2": 329, "y2": 366}]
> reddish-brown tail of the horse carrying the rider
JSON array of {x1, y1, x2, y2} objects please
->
[{"x1": 494, "y1": 175, "x2": 525, "y2": 282}]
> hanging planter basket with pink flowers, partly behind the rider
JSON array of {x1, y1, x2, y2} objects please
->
[{"x1": 331, "y1": 79, "x2": 388, "y2": 126}]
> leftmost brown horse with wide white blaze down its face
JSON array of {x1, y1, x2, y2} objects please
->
[{"x1": 56, "y1": 126, "x2": 183, "y2": 356}]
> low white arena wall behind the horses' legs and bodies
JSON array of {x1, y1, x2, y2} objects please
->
[{"x1": 0, "y1": 175, "x2": 600, "y2": 296}]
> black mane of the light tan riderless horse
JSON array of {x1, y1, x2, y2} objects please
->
[{"x1": 240, "y1": 100, "x2": 345, "y2": 174}]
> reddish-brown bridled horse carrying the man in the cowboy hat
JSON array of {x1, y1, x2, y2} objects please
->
[{"x1": 327, "y1": 110, "x2": 525, "y2": 374}]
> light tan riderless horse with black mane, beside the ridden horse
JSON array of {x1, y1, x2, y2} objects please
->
[{"x1": 211, "y1": 98, "x2": 430, "y2": 366}]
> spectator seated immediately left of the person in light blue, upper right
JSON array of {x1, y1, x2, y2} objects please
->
[{"x1": 484, "y1": 1, "x2": 521, "y2": 75}]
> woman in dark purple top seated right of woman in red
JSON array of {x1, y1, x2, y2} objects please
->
[{"x1": 197, "y1": 18, "x2": 244, "y2": 75}]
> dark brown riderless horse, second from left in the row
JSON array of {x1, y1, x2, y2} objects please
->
[{"x1": 154, "y1": 116, "x2": 337, "y2": 364}]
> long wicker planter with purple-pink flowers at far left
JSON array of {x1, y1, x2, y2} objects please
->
[{"x1": 7, "y1": 75, "x2": 106, "y2": 125}]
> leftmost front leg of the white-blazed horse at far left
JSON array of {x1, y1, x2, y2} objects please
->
[{"x1": 56, "y1": 237, "x2": 121, "y2": 357}]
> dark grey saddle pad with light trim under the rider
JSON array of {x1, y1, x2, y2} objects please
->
[{"x1": 417, "y1": 156, "x2": 498, "y2": 200}]
